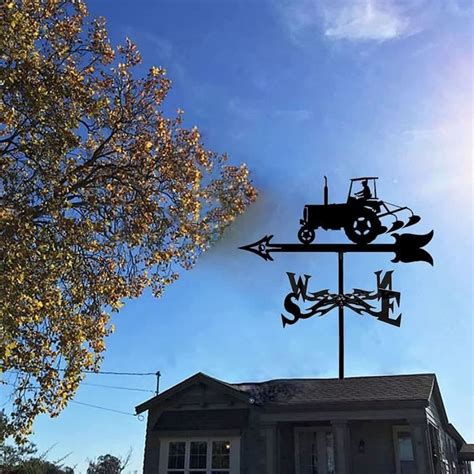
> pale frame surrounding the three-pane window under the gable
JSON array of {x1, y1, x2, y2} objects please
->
[{"x1": 158, "y1": 435, "x2": 240, "y2": 474}]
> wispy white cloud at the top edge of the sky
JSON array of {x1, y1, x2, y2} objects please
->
[{"x1": 275, "y1": 0, "x2": 436, "y2": 43}]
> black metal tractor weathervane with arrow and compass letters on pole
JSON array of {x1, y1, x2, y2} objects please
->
[{"x1": 240, "y1": 176, "x2": 433, "y2": 379}]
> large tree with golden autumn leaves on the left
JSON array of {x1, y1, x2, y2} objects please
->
[{"x1": 0, "y1": 0, "x2": 256, "y2": 438}]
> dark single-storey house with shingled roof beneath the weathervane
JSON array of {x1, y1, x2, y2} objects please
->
[{"x1": 136, "y1": 373, "x2": 474, "y2": 474}]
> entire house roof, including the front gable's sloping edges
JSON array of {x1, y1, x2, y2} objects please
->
[{"x1": 135, "y1": 372, "x2": 436, "y2": 413}]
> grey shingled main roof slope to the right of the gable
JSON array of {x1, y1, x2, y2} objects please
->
[{"x1": 226, "y1": 374, "x2": 435, "y2": 405}]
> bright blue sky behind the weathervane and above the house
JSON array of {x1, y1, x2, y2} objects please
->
[{"x1": 8, "y1": 0, "x2": 474, "y2": 472}]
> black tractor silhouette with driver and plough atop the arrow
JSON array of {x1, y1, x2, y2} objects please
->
[{"x1": 298, "y1": 176, "x2": 421, "y2": 245}]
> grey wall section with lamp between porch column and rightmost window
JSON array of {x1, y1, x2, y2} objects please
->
[{"x1": 349, "y1": 421, "x2": 398, "y2": 474}]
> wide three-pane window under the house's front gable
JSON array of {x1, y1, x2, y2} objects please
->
[{"x1": 159, "y1": 438, "x2": 240, "y2": 474}]
